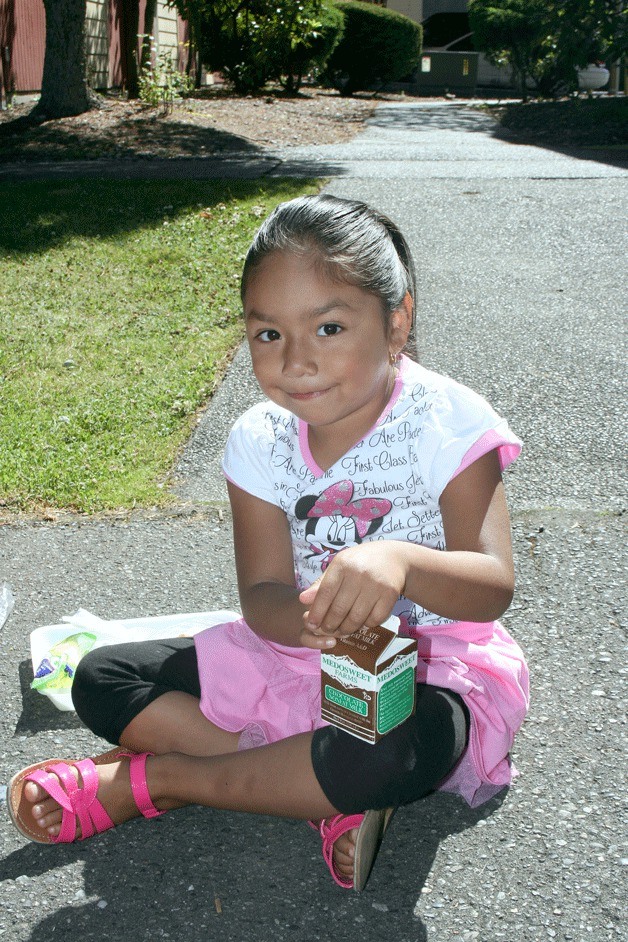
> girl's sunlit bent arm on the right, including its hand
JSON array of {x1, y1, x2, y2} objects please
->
[{"x1": 301, "y1": 451, "x2": 514, "y2": 647}]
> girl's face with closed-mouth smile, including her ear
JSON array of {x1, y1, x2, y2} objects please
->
[{"x1": 244, "y1": 252, "x2": 411, "y2": 458}]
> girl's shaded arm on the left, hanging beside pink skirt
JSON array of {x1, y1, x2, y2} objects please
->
[{"x1": 227, "y1": 482, "x2": 333, "y2": 648}]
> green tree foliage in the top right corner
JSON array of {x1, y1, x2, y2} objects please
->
[{"x1": 469, "y1": 0, "x2": 627, "y2": 98}]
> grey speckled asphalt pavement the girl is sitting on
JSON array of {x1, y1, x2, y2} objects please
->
[{"x1": 0, "y1": 103, "x2": 628, "y2": 942}]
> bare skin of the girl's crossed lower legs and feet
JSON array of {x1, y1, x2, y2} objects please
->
[{"x1": 25, "y1": 692, "x2": 355, "y2": 876}]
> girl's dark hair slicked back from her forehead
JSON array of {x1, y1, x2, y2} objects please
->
[{"x1": 240, "y1": 194, "x2": 415, "y2": 342}]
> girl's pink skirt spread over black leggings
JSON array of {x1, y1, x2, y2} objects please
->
[{"x1": 194, "y1": 619, "x2": 529, "y2": 807}]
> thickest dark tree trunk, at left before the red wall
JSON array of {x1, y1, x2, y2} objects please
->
[{"x1": 33, "y1": 0, "x2": 92, "y2": 118}]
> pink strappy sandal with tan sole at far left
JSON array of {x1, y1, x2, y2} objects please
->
[{"x1": 7, "y1": 749, "x2": 164, "y2": 844}]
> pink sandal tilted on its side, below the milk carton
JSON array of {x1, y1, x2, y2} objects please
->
[{"x1": 308, "y1": 808, "x2": 396, "y2": 893}]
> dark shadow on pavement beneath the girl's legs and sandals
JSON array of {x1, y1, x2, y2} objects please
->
[{"x1": 0, "y1": 792, "x2": 506, "y2": 942}]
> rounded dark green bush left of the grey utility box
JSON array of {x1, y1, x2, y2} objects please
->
[{"x1": 324, "y1": 0, "x2": 422, "y2": 95}]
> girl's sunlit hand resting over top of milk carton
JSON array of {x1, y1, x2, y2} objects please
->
[{"x1": 299, "y1": 540, "x2": 407, "y2": 650}]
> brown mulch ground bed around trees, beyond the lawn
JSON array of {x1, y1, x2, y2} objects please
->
[{"x1": 0, "y1": 88, "x2": 392, "y2": 161}]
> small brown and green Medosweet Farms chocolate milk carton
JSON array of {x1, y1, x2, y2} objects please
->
[{"x1": 321, "y1": 615, "x2": 417, "y2": 743}]
